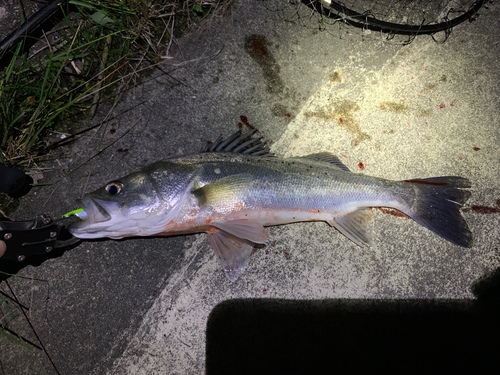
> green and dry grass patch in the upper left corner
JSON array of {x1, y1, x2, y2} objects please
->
[{"x1": 0, "y1": 0, "x2": 234, "y2": 170}]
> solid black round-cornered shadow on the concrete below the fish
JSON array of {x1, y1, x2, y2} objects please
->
[{"x1": 206, "y1": 269, "x2": 500, "y2": 375}]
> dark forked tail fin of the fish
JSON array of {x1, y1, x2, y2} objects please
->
[{"x1": 405, "y1": 176, "x2": 472, "y2": 247}]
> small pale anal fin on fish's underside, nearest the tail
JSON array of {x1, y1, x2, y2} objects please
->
[{"x1": 328, "y1": 208, "x2": 372, "y2": 247}]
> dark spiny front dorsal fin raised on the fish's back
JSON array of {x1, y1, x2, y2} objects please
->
[{"x1": 201, "y1": 129, "x2": 273, "y2": 156}]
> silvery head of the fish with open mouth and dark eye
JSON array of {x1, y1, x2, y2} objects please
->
[{"x1": 68, "y1": 161, "x2": 201, "y2": 239}]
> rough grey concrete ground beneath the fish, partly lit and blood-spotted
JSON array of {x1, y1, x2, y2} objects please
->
[{"x1": 0, "y1": 1, "x2": 500, "y2": 375}]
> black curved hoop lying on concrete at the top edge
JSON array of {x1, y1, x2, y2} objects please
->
[{"x1": 302, "y1": 0, "x2": 486, "y2": 36}]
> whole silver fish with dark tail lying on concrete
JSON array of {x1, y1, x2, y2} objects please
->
[{"x1": 68, "y1": 129, "x2": 473, "y2": 281}]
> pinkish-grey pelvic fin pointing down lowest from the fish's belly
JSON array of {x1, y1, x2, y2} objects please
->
[{"x1": 207, "y1": 228, "x2": 253, "y2": 281}]
